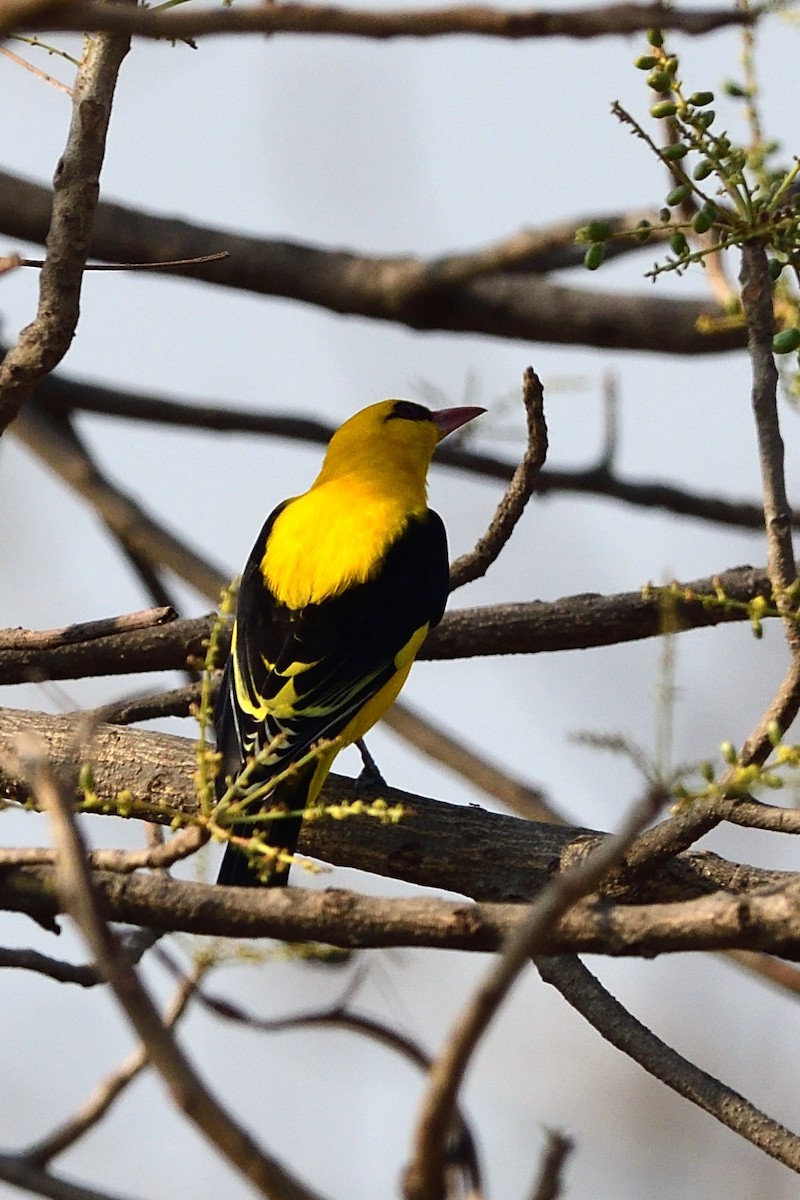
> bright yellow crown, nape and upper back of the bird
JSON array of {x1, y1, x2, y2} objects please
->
[{"x1": 261, "y1": 400, "x2": 439, "y2": 608}]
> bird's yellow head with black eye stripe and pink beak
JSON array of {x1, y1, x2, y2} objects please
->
[{"x1": 320, "y1": 400, "x2": 486, "y2": 481}]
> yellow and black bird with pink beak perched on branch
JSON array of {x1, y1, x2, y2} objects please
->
[{"x1": 213, "y1": 400, "x2": 486, "y2": 887}]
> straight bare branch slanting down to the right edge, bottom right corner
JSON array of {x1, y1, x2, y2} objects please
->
[{"x1": 535, "y1": 958, "x2": 800, "y2": 1172}]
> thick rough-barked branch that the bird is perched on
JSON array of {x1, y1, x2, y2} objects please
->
[{"x1": 0, "y1": 709, "x2": 793, "y2": 907}]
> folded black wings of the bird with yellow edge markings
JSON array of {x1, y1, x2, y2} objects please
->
[{"x1": 215, "y1": 506, "x2": 449, "y2": 790}]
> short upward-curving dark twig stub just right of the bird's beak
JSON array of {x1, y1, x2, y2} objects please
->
[{"x1": 450, "y1": 367, "x2": 547, "y2": 592}]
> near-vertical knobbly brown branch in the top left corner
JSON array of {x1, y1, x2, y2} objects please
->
[{"x1": 0, "y1": 12, "x2": 136, "y2": 433}]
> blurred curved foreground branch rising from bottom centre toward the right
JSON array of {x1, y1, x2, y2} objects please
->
[{"x1": 405, "y1": 788, "x2": 666, "y2": 1200}]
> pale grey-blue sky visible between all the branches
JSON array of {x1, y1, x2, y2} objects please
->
[{"x1": 0, "y1": 9, "x2": 800, "y2": 1200}]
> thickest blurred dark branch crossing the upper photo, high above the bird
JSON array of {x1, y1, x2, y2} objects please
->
[{"x1": 0, "y1": 170, "x2": 745, "y2": 354}]
